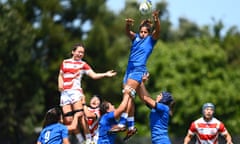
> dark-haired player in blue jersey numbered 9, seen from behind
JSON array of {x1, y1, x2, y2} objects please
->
[{"x1": 37, "y1": 107, "x2": 80, "y2": 144}]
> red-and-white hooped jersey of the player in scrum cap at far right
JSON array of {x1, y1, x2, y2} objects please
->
[{"x1": 188, "y1": 117, "x2": 227, "y2": 144}]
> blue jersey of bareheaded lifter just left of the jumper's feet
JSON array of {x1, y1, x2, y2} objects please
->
[{"x1": 98, "y1": 112, "x2": 117, "y2": 144}]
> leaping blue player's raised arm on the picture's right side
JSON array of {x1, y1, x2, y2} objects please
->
[{"x1": 152, "y1": 11, "x2": 160, "y2": 40}]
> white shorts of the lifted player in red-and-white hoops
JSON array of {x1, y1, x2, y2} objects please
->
[{"x1": 60, "y1": 90, "x2": 84, "y2": 106}]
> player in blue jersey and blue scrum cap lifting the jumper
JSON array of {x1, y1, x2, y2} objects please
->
[{"x1": 139, "y1": 76, "x2": 175, "y2": 144}]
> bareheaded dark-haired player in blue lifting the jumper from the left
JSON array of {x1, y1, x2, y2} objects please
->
[{"x1": 98, "y1": 95, "x2": 130, "y2": 144}]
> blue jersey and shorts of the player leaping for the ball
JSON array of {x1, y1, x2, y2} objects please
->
[{"x1": 123, "y1": 34, "x2": 156, "y2": 84}]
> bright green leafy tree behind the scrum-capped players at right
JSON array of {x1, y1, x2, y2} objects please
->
[{"x1": 148, "y1": 38, "x2": 240, "y2": 135}]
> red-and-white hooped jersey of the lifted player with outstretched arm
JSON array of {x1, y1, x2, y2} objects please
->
[{"x1": 60, "y1": 59, "x2": 92, "y2": 90}]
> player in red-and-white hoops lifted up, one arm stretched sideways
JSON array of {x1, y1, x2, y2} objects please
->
[{"x1": 58, "y1": 44, "x2": 116, "y2": 143}]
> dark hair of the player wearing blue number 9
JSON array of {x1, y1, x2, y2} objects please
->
[{"x1": 43, "y1": 107, "x2": 62, "y2": 128}]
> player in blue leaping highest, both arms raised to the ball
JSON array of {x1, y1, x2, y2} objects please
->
[{"x1": 110, "y1": 11, "x2": 160, "y2": 140}]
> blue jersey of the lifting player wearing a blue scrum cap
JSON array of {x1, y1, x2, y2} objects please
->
[{"x1": 150, "y1": 103, "x2": 171, "y2": 144}]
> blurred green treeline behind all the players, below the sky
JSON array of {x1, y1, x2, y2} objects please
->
[{"x1": 0, "y1": 0, "x2": 240, "y2": 143}]
